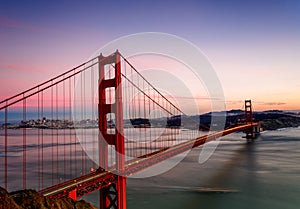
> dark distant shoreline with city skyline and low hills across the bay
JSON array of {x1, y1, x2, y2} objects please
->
[{"x1": 0, "y1": 110, "x2": 300, "y2": 130}]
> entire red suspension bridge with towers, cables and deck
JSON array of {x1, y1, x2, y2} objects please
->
[{"x1": 0, "y1": 51, "x2": 259, "y2": 209}]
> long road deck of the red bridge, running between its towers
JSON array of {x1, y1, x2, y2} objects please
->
[{"x1": 39, "y1": 122, "x2": 258, "y2": 198}]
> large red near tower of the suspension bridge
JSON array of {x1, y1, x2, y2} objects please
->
[{"x1": 98, "y1": 51, "x2": 126, "y2": 209}]
